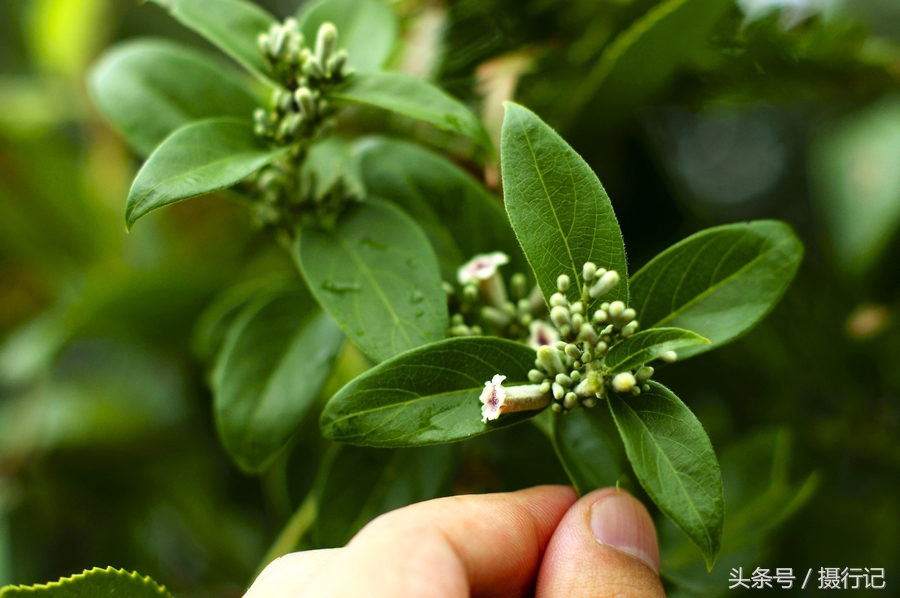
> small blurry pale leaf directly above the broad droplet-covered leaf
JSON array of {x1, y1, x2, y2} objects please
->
[{"x1": 300, "y1": 137, "x2": 366, "y2": 201}]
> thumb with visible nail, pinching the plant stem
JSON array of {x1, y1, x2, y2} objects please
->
[{"x1": 536, "y1": 488, "x2": 665, "y2": 598}]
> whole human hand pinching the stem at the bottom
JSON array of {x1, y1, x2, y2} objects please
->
[{"x1": 244, "y1": 486, "x2": 665, "y2": 598}]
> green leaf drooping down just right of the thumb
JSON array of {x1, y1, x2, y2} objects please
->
[{"x1": 608, "y1": 381, "x2": 725, "y2": 569}]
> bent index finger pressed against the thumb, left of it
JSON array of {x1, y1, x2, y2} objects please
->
[{"x1": 298, "y1": 486, "x2": 576, "y2": 598}]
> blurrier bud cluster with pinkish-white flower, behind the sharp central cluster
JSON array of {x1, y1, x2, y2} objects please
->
[{"x1": 445, "y1": 251, "x2": 544, "y2": 348}]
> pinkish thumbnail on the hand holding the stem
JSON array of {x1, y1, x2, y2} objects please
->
[{"x1": 591, "y1": 491, "x2": 659, "y2": 573}]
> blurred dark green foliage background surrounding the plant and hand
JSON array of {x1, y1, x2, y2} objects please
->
[{"x1": 0, "y1": 0, "x2": 900, "y2": 596}]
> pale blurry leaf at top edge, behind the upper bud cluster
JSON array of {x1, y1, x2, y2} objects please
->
[{"x1": 300, "y1": 0, "x2": 399, "y2": 73}]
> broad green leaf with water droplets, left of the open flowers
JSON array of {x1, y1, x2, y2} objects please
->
[{"x1": 296, "y1": 198, "x2": 448, "y2": 362}]
